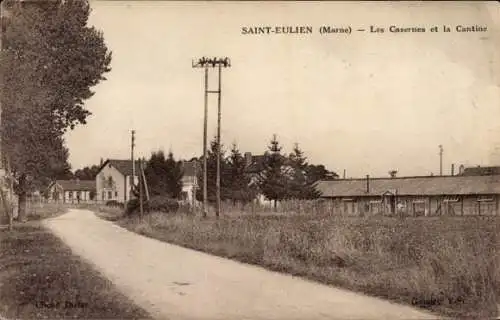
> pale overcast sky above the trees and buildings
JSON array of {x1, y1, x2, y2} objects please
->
[{"x1": 67, "y1": 1, "x2": 500, "y2": 177}]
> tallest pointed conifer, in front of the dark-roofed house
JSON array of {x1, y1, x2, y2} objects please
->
[{"x1": 259, "y1": 135, "x2": 288, "y2": 209}]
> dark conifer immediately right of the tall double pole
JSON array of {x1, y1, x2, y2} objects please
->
[{"x1": 224, "y1": 143, "x2": 257, "y2": 203}]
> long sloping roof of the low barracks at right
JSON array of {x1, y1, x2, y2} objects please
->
[{"x1": 316, "y1": 175, "x2": 500, "y2": 198}]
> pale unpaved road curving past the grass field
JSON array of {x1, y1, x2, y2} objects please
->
[{"x1": 44, "y1": 210, "x2": 442, "y2": 320}]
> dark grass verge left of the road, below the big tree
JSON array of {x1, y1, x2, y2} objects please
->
[{"x1": 0, "y1": 221, "x2": 149, "y2": 319}]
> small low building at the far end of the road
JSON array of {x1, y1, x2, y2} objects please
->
[{"x1": 47, "y1": 180, "x2": 96, "y2": 203}]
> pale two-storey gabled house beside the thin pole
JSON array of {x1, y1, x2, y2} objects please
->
[{"x1": 94, "y1": 159, "x2": 139, "y2": 203}]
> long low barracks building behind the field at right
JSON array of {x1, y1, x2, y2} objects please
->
[{"x1": 316, "y1": 175, "x2": 500, "y2": 216}]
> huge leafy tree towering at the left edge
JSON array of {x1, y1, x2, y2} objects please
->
[{"x1": 0, "y1": 0, "x2": 111, "y2": 220}]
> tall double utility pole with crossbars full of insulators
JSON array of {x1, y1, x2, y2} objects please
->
[{"x1": 192, "y1": 57, "x2": 231, "y2": 217}]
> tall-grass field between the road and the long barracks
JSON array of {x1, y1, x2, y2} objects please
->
[{"x1": 118, "y1": 213, "x2": 500, "y2": 318}]
